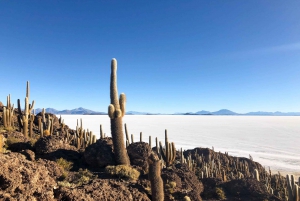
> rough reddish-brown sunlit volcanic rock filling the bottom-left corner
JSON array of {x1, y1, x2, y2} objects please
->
[{"x1": 0, "y1": 152, "x2": 57, "y2": 201}]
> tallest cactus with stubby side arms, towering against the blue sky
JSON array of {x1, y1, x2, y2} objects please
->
[{"x1": 108, "y1": 59, "x2": 130, "y2": 165}]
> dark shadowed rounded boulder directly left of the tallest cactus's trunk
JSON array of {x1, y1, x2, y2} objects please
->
[{"x1": 84, "y1": 137, "x2": 115, "y2": 168}]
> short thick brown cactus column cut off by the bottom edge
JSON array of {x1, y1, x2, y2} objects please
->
[{"x1": 148, "y1": 153, "x2": 164, "y2": 201}]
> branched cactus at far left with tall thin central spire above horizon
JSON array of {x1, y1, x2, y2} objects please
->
[{"x1": 18, "y1": 81, "x2": 34, "y2": 137}]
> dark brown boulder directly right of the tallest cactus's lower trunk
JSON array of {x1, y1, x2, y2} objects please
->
[{"x1": 127, "y1": 142, "x2": 152, "y2": 174}]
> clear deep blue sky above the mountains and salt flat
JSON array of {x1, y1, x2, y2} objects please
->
[{"x1": 0, "y1": 0, "x2": 300, "y2": 113}]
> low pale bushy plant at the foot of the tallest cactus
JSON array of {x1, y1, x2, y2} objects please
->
[{"x1": 105, "y1": 165, "x2": 140, "y2": 180}]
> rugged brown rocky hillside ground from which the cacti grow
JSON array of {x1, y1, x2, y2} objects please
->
[{"x1": 0, "y1": 106, "x2": 290, "y2": 201}]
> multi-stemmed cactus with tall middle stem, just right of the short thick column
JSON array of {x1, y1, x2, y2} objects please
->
[{"x1": 159, "y1": 130, "x2": 176, "y2": 167}]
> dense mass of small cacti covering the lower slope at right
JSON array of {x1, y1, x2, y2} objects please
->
[{"x1": 180, "y1": 146, "x2": 300, "y2": 201}]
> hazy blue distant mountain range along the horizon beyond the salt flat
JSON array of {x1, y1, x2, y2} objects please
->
[{"x1": 35, "y1": 107, "x2": 300, "y2": 116}]
